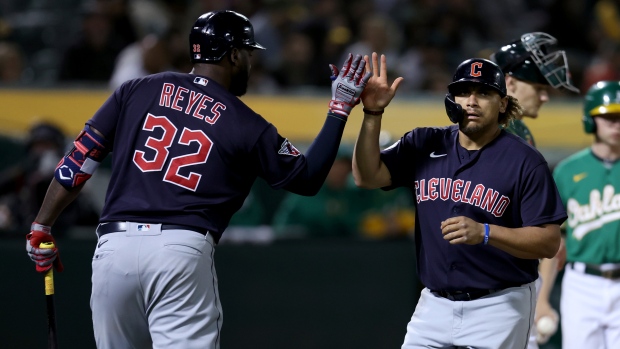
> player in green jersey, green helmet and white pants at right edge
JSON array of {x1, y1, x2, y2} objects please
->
[{"x1": 553, "y1": 81, "x2": 620, "y2": 349}]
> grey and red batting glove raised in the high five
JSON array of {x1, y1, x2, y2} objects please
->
[{"x1": 329, "y1": 53, "x2": 372, "y2": 119}]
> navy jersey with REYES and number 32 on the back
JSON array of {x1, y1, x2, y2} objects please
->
[{"x1": 87, "y1": 73, "x2": 324, "y2": 240}]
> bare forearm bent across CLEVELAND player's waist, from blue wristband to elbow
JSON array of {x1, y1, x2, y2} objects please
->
[{"x1": 489, "y1": 224, "x2": 560, "y2": 259}]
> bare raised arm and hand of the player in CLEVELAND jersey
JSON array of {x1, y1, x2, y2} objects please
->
[{"x1": 353, "y1": 52, "x2": 403, "y2": 188}]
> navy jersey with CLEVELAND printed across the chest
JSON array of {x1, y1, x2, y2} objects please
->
[{"x1": 381, "y1": 125, "x2": 566, "y2": 291}]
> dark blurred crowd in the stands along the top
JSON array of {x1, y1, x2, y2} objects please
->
[{"x1": 0, "y1": 0, "x2": 620, "y2": 93}]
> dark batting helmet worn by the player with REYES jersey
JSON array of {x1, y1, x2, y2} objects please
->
[{"x1": 189, "y1": 11, "x2": 265, "y2": 63}]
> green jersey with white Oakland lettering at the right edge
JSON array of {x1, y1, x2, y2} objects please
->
[{"x1": 553, "y1": 148, "x2": 620, "y2": 265}]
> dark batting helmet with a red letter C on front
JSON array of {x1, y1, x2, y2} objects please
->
[{"x1": 445, "y1": 58, "x2": 506, "y2": 124}]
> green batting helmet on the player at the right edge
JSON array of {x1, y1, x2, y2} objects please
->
[{"x1": 582, "y1": 81, "x2": 620, "y2": 133}]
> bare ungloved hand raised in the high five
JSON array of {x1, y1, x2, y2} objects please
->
[{"x1": 361, "y1": 52, "x2": 404, "y2": 112}]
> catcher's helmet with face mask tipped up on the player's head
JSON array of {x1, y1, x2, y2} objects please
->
[{"x1": 491, "y1": 32, "x2": 579, "y2": 93}]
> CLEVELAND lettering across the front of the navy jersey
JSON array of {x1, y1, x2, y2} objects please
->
[{"x1": 415, "y1": 178, "x2": 510, "y2": 217}]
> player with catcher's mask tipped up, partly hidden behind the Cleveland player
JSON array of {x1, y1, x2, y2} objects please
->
[{"x1": 490, "y1": 32, "x2": 579, "y2": 349}]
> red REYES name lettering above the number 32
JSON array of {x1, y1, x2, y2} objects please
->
[{"x1": 159, "y1": 83, "x2": 226, "y2": 125}]
